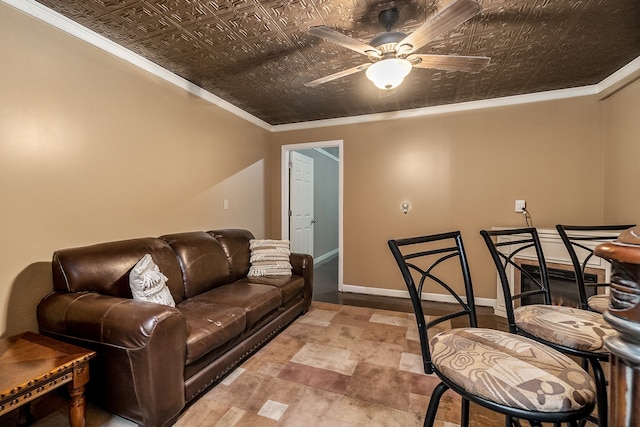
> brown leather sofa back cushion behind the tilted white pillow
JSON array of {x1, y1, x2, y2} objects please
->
[{"x1": 52, "y1": 237, "x2": 184, "y2": 303}]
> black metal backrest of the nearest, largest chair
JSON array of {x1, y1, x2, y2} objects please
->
[{"x1": 388, "y1": 231, "x2": 478, "y2": 374}]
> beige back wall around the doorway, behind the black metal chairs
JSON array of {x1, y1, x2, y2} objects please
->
[{"x1": 272, "y1": 97, "x2": 603, "y2": 298}]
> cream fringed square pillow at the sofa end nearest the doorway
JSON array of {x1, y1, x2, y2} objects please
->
[{"x1": 247, "y1": 239, "x2": 291, "y2": 277}]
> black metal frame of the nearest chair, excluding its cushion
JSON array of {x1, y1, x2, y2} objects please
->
[{"x1": 388, "y1": 231, "x2": 593, "y2": 427}]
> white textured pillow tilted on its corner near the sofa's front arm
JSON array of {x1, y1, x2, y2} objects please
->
[{"x1": 129, "y1": 254, "x2": 176, "y2": 307}]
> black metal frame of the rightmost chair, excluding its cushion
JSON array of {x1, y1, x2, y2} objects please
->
[{"x1": 556, "y1": 224, "x2": 635, "y2": 310}]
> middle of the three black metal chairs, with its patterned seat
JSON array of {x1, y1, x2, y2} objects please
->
[{"x1": 480, "y1": 228, "x2": 615, "y2": 427}]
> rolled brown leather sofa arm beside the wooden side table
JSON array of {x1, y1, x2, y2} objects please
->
[{"x1": 37, "y1": 292, "x2": 186, "y2": 427}]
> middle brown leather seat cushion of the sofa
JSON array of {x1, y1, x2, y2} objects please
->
[{"x1": 197, "y1": 281, "x2": 282, "y2": 330}]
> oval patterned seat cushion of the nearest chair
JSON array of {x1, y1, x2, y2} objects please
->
[{"x1": 430, "y1": 328, "x2": 595, "y2": 412}]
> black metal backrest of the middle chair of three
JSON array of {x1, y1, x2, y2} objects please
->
[{"x1": 480, "y1": 227, "x2": 551, "y2": 332}]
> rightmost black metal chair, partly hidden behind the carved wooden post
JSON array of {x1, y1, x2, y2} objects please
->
[{"x1": 556, "y1": 224, "x2": 634, "y2": 313}]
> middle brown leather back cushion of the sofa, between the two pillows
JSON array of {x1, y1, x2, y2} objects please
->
[{"x1": 160, "y1": 231, "x2": 231, "y2": 299}]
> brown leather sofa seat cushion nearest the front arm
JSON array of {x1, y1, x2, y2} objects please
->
[{"x1": 176, "y1": 297, "x2": 247, "y2": 365}]
